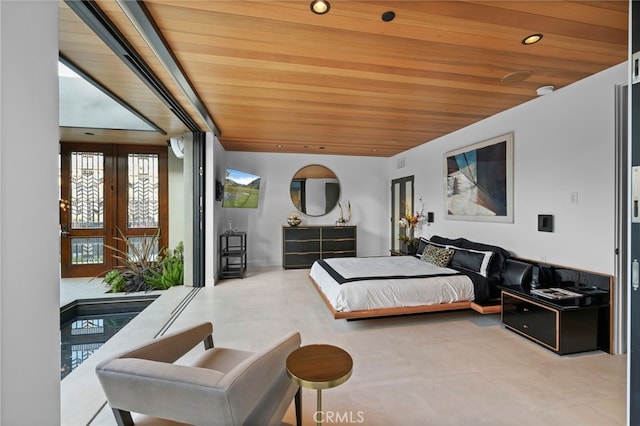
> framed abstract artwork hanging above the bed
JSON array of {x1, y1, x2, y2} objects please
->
[{"x1": 444, "y1": 133, "x2": 513, "y2": 223}]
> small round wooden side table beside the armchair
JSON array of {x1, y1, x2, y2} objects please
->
[{"x1": 286, "y1": 345, "x2": 353, "y2": 425}]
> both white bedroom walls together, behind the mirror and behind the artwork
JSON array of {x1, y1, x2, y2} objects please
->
[{"x1": 209, "y1": 64, "x2": 627, "y2": 274}]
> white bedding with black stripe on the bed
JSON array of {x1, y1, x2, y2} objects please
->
[{"x1": 309, "y1": 256, "x2": 474, "y2": 312}]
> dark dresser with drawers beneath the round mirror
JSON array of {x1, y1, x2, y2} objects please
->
[{"x1": 282, "y1": 226, "x2": 357, "y2": 269}]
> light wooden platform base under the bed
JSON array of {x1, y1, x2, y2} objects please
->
[{"x1": 309, "y1": 277, "x2": 501, "y2": 320}]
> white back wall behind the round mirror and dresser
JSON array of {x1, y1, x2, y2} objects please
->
[{"x1": 213, "y1": 151, "x2": 390, "y2": 267}]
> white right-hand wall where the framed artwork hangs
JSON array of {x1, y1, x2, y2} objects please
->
[{"x1": 389, "y1": 63, "x2": 627, "y2": 274}]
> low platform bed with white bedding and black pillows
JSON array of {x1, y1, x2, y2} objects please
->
[{"x1": 309, "y1": 236, "x2": 522, "y2": 319}]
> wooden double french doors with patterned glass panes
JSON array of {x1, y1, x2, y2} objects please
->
[{"x1": 60, "y1": 143, "x2": 168, "y2": 278}]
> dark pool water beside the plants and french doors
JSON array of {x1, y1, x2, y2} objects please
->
[{"x1": 60, "y1": 296, "x2": 157, "y2": 380}]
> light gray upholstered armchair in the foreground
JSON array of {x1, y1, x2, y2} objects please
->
[{"x1": 96, "y1": 323, "x2": 300, "y2": 426}]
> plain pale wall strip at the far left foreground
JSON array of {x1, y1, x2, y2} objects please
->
[{"x1": 0, "y1": 1, "x2": 60, "y2": 426}]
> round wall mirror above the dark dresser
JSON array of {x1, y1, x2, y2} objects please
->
[{"x1": 289, "y1": 164, "x2": 340, "y2": 216}]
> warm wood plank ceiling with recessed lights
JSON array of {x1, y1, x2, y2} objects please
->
[{"x1": 60, "y1": 0, "x2": 628, "y2": 157}]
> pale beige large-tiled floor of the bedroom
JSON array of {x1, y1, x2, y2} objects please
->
[{"x1": 61, "y1": 268, "x2": 626, "y2": 426}]
